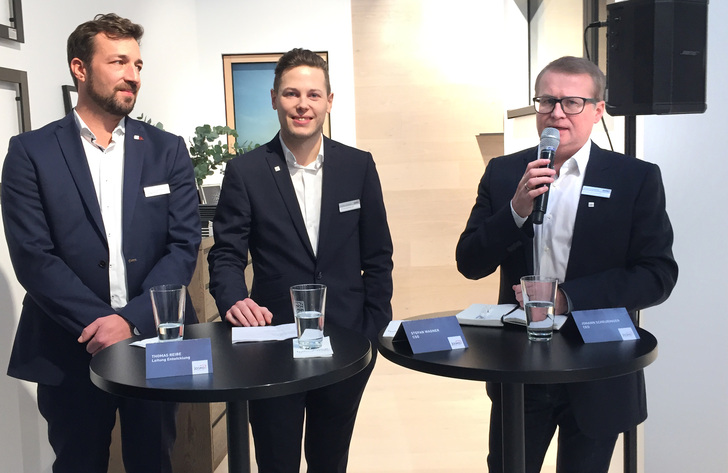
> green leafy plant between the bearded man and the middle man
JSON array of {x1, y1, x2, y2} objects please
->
[{"x1": 190, "y1": 125, "x2": 260, "y2": 185}]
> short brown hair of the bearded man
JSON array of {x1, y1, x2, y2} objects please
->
[{"x1": 66, "y1": 13, "x2": 144, "y2": 87}]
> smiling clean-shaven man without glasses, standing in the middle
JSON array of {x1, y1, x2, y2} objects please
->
[{"x1": 209, "y1": 49, "x2": 392, "y2": 473}]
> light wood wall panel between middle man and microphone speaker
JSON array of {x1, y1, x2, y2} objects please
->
[{"x1": 351, "y1": 0, "x2": 503, "y2": 318}]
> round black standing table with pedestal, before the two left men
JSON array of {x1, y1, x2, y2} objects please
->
[{"x1": 90, "y1": 322, "x2": 372, "y2": 473}]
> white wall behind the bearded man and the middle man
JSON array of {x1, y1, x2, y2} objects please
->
[{"x1": 0, "y1": 0, "x2": 356, "y2": 473}]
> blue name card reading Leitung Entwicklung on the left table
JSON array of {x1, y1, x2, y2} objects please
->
[{"x1": 146, "y1": 338, "x2": 212, "y2": 379}]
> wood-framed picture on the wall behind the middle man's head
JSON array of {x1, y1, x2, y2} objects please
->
[{"x1": 222, "y1": 52, "x2": 331, "y2": 147}]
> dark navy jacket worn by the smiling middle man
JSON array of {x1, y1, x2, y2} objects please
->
[{"x1": 208, "y1": 136, "x2": 393, "y2": 341}]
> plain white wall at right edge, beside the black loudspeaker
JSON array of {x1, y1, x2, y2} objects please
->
[{"x1": 643, "y1": 1, "x2": 728, "y2": 473}]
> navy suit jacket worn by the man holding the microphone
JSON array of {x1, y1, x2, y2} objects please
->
[{"x1": 456, "y1": 144, "x2": 678, "y2": 434}]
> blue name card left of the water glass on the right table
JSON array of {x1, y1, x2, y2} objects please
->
[{"x1": 392, "y1": 315, "x2": 468, "y2": 353}]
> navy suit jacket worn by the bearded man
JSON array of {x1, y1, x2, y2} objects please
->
[{"x1": 2, "y1": 112, "x2": 200, "y2": 385}]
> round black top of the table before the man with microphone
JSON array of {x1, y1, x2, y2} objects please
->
[{"x1": 379, "y1": 311, "x2": 657, "y2": 384}]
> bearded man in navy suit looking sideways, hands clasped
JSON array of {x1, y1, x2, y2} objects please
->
[{"x1": 2, "y1": 14, "x2": 200, "y2": 473}]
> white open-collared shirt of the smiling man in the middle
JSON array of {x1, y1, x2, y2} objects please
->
[{"x1": 280, "y1": 137, "x2": 324, "y2": 255}]
